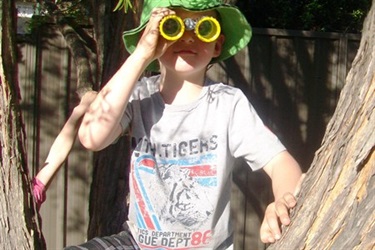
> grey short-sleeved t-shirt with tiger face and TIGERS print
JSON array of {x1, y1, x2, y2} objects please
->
[{"x1": 121, "y1": 76, "x2": 285, "y2": 249}]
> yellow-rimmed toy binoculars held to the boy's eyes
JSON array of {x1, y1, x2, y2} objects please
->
[{"x1": 159, "y1": 15, "x2": 221, "y2": 43}]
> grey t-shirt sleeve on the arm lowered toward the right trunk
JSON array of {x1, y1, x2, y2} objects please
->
[{"x1": 229, "y1": 90, "x2": 285, "y2": 170}]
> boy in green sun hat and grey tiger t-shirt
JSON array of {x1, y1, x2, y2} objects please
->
[{"x1": 71, "y1": 0, "x2": 301, "y2": 249}]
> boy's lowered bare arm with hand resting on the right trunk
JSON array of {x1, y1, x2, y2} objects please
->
[{"x1": 260, "y1": 151, "x2": 302, "y2": 243}]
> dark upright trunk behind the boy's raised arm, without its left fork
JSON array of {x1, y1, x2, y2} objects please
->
[{"x1": 87, "y1": 0, "x2": 141, "y2": 239}]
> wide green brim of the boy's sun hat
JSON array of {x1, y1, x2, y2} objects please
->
[{"x1": 123, "y1": 4, "x2": 252, "y2": 71}]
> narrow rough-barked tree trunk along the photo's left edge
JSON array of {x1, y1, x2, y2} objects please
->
[{"x1": 0, "y1": 0, "x2": 45, "y2": 250}]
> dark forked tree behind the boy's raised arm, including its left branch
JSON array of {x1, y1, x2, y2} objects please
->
[{"x1": 31, "y1": 0, "x2": 141, "y2": 239}]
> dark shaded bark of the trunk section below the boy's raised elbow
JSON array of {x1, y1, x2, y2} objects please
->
[{"x1": 87, "y1": 136, "x2": 130, "y2": 239}]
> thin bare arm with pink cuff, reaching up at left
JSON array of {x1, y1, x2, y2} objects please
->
[{"x1": 32, "y1": 91, "x2": 97, "y2": 210}]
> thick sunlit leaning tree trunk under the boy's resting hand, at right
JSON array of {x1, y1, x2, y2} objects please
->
[{"x1": 268, "y1": 1, "x2": 375, "y2": 249}]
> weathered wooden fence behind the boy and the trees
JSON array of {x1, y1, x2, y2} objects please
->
[{"x1": 19, "y1": 29, "x2": 360, "y2": 250}]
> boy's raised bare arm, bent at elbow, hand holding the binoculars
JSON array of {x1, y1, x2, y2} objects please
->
[{"x1": 78, "y1": 8, "x2": 178, "y2": 150}]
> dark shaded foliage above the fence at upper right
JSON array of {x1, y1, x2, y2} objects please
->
[{"x1": 237, "y1": 0, "x2": 372, "y2": 33}]
